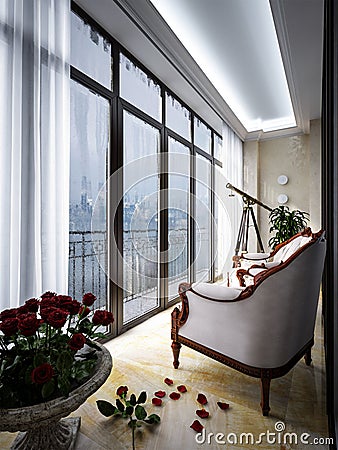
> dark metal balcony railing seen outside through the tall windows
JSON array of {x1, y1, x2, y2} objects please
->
[{"x1": 68, "y1": 229, "x2": 208, "y2": 321}]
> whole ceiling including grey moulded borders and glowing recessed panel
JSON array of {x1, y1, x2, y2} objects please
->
[{"x1": 76, "y1": 0, "x2": 323, "y2": 139}]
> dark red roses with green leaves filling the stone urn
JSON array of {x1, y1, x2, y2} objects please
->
[{"x1": 0, "y1": 292, "x2": 114, "y2": 408}]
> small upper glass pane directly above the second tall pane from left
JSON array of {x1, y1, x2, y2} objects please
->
[{"x1": 120, "y1": 53, "x2": 162, "y2": 122}]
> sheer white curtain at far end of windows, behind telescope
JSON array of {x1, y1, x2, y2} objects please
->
[{"x1": 216, "y1": 123, "x2": 243, "y2": 276}]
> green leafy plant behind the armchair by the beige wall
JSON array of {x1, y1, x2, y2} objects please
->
[{"x1": 268, "y1": 206, "x2": 309, "y2": 250}]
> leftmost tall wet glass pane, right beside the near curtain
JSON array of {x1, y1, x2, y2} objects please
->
[{"x1": 68, "y1": 81, "x2": 110, "y2": 308}]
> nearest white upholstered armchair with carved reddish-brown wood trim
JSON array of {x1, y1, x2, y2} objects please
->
[{"x1": 171, "y1": 230, "x2": 326, "y2": 415}]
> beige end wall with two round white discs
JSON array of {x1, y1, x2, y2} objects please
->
[{"x1": 244, "y1": 120, "x2": 321, "y2": 251}]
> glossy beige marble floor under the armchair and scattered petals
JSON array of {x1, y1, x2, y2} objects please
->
[{"x1": 0, "y1": 302, "x2": 328, "y2": 450}]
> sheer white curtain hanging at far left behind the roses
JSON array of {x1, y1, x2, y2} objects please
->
[{"x1": 0, "y1": 0, "x2": 70, "y2": 309}]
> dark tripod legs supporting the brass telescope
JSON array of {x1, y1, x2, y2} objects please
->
[{"x1": 233, "y1": 198, "x2": 264, "y2": 267}]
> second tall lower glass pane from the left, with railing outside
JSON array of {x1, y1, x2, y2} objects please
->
[{"x1": 123, "y1": 111, "x2": 159, "y2": 323}]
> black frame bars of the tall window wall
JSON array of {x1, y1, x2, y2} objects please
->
[{"x1": 70, "y1": 1, "x2": 222, "y2": 339}]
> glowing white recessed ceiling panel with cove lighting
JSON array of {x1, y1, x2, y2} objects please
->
[{"x1": 151, "y1": 0, "x2": 296, "y2": 131}]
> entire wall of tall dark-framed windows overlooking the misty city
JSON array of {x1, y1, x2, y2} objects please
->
[{"x1": 69, "y1": 5, "x2": 227, "y2": 333}]
